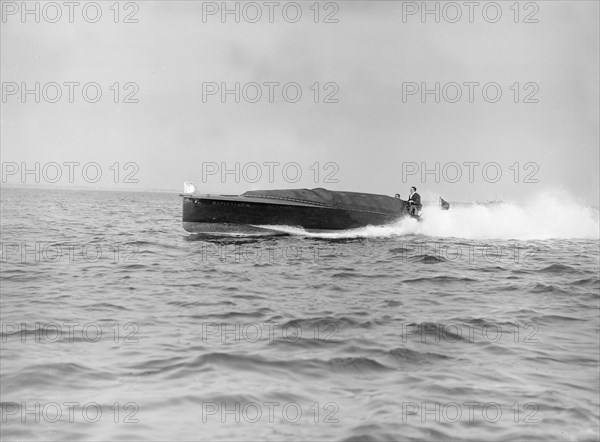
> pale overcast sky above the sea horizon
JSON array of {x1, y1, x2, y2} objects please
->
[{"x1": 0, "y1": 1, "x2": 600, "y2": 204}]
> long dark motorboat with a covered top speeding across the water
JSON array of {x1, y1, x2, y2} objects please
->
[{"x1": 182, "y1": 189, "x2": 409, "y2": 234}]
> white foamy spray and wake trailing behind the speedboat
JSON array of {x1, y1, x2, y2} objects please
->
[{"x1": 271, "y1": 194, "x2": 600, "y2": 240}]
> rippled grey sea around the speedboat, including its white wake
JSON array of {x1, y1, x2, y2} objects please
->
[{"x1": 0, "y1": 189, "x2": 600, "y2": 440}]
